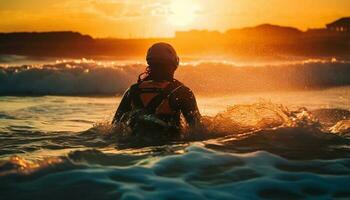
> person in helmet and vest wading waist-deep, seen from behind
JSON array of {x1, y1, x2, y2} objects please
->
[{"x1": 113, "y1": 43, "x2": 201, "y2": 136}]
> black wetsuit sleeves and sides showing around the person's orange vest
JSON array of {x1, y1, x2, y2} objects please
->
[{"x1": 113, "y1": 79, "x2": 201, "y2": 126}]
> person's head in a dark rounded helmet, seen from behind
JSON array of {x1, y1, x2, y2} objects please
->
[{"x1": 139, "y1": 42, "x2": 179, "y2": 80}]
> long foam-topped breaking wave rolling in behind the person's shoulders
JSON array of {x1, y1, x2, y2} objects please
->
[{"x1": 0, "y1": 59, "x2": 350, "y2": 95}]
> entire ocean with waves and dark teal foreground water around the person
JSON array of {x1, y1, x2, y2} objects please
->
[{"x1": 0, "y1": 59, "x2": 350, "y2": 200}]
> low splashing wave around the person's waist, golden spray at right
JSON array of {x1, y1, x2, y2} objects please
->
[{"x1": 0, "y1": 102, "x2": 350, "y2": 158}]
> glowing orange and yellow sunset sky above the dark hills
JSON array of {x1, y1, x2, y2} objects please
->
[{"x1": 0, "y1": 0, "x2": 350, "y2": 37}]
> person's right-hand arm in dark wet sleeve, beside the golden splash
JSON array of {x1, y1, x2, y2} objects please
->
[{"x1": 176, "y1": 86, "x2": 201, "y2": 127}]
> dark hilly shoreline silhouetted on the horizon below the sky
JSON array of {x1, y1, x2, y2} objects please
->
[{"x1": 0, "y1": 24, "x2": 350, "y2": 58}]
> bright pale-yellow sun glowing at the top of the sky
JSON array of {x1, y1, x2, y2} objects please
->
[{"x1": 169, "y1": 0, "x2": 198, "y2": 27}]
